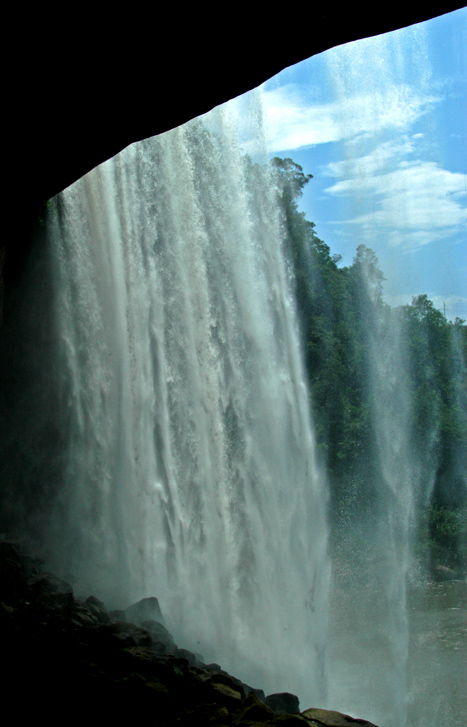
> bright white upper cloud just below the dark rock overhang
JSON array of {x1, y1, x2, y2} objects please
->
[{"x1": 261, "y1": 84, "x2": 439, "y2": 152}]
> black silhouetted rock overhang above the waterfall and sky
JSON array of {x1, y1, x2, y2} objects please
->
[{"x1": 0, "y1": 2, "x2": 463, "y2": 316}]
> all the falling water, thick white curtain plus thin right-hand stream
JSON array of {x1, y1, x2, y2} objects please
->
[{"x1": 0, "y1": 21, "x2": 465, "y2": 727}]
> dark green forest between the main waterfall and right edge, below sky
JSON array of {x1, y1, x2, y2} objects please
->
[{"x1": 268, "y1": 157, "x2": 467, "y2": 570}]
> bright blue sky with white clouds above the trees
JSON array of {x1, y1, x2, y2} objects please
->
[{"x1": 232, "y1": 8, "x2": 467, "y2": 320}]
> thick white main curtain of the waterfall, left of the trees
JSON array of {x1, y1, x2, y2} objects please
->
[{"x1": 10, "y1": 105, "x2": 329, "y2": 708}]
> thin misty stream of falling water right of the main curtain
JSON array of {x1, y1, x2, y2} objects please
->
[{"x1": 320, "y1": 19, "x2": 462, "y2": 727}]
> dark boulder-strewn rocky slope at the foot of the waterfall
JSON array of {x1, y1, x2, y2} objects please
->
[{"x1": 0, "y1": 540, "x2": 375, "y2": 727}]
